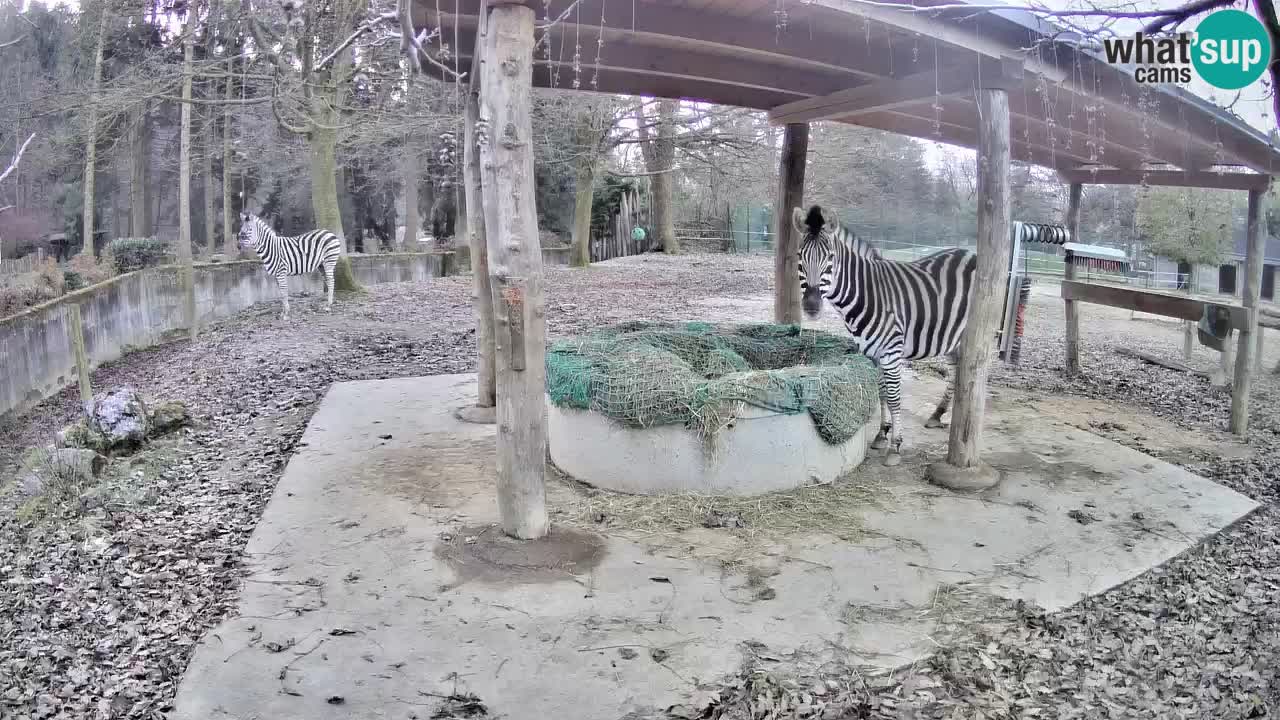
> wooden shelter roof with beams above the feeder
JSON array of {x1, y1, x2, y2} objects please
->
[{"x1": 413, "y1": 0, "x2": 1280, "y2": 187}]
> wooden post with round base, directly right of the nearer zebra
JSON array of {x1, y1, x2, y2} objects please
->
[{"x1": 929, "y1": 82, "x2": 1010, "y2": 481}]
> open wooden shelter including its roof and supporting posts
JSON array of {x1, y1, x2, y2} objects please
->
[{"x1": 402, "y1": 0, "x2": 1280, "y2": 538}]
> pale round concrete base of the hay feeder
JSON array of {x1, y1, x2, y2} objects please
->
[{"x1": 547, "y1": 402, "x2": 879, "y2": 495}]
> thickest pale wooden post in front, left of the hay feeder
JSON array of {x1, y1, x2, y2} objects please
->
[{"x1": 477, "y1": 4, "x2": 548, "y2": 539}]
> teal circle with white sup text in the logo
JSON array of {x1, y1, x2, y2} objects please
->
[{"x1": 1192, "y1": 10, "x2": 1274, "y2": 90}]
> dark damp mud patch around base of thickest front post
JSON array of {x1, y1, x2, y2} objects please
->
[{"x1": 435, "y1": 525, "x2": 605, "y2": 587}]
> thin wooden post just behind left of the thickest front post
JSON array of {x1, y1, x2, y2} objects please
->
[{"x1": 463, "y1": 8, "x2": 497, "y2": 412}]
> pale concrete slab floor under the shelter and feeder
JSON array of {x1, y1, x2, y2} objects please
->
[{"x1": 172, "y1": 375, "x2": 1256, "y2": 720}]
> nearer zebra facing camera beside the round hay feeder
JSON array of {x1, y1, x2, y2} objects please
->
[{"x1": 791, "y1": 205, "x2": 978, "y2": 465}]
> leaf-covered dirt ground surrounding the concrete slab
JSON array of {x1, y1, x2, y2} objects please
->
[{"x1": 0, "y1": 255, "x2": 1280, "y2": 719}]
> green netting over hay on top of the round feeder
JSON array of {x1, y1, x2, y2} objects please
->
[{"x1": 547, "y1": 323, "x2": 879, "y2": 445}]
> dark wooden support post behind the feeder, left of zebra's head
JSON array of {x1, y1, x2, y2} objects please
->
[{"x1": 773, "y1": 123, "x2": 809, "y2": 324}]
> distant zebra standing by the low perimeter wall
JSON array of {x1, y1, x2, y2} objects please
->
[{"x1": 239, "y1": 213, "x2": 342, "y2": 320}]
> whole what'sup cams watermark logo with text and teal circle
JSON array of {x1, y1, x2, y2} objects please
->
[{"x1": 1102, "y1": 10, "x2": 1274, "y2": 90}]
